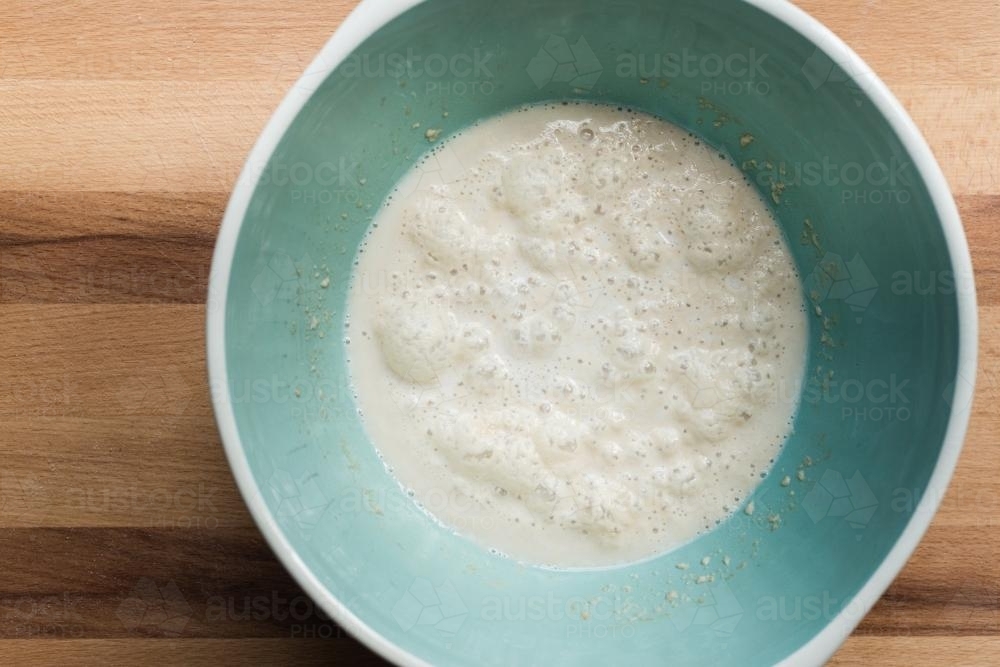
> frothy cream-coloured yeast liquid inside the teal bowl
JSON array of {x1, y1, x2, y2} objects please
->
[{"x1": 347, "y1": 104, "x2": 807, "y2": 567}]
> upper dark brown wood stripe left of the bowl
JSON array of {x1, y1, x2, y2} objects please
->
[{"x1": 0, "y1": 192, "x2": 225, "y2": 303}]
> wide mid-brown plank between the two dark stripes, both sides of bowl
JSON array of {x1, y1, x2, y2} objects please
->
[{"x1": 0, "y1": 305, "x2": 1000, "y2": 528}]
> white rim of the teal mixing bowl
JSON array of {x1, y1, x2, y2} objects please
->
[{"x1": 206, "y1": 0, "x2": 978, "y2": 667}]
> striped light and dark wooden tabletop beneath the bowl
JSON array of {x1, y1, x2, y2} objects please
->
[{"x1": 0, "y1": 0, "x2": 1000, "y2": 666}]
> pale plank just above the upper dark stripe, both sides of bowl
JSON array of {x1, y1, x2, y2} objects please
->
[{"x1": 0, "y1": 85, "x2": 1000, "y2": 195}]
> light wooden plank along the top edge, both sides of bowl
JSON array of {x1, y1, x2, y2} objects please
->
[{"x1": 0, "y1": 0, "x2": 1000, "y2": 85}]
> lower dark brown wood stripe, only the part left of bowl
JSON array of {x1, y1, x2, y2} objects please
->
[{"x1": 0, "y1": 528, "x2": 354, "y2": 639}]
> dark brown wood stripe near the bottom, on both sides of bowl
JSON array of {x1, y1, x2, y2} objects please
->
[{"x1": 0, "y1": 528, "x2": 1000, "y2": 639}]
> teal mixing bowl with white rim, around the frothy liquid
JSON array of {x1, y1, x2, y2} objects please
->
[{"x1": 208, "y1": 0, "x2": 977, "y2": 666}]
